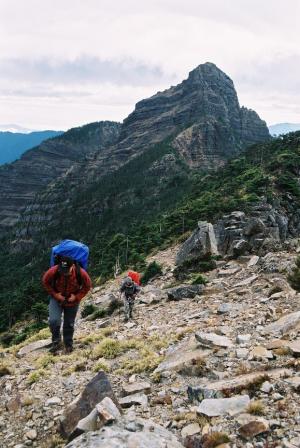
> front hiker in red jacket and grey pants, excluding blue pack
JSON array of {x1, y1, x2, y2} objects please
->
[{"x1": 43, "y1": 257, "x2": 92, "y2": 353}]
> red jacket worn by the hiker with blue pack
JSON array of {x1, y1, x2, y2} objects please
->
[{"x1": 43, "y1": 265, "x2": 92, "y2": 306}]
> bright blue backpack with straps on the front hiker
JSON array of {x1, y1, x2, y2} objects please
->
[{"x1": 50, "y1": 240, "x2": 89, "y2": 290}]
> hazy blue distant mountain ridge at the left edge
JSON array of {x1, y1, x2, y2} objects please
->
[{"x1": 0, "y1": 130, "x2": 63, "y2": 165}]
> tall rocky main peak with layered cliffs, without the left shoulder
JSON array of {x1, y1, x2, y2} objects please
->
[{"x1": 119, "y1": 63, "x2": 270, "y2": 168}]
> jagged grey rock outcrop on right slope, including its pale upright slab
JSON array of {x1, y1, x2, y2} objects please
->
[{"x1": 176, "y1": 200, "x2": 300, "y2": 266}]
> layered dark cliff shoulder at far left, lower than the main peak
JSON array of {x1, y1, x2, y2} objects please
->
[{"x1": 0, "y1": 121, "x2": 120, "y2": 232}]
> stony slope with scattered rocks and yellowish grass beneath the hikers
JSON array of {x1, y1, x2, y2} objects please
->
[{"x1": 0, "y1": 243, "x2": 300, "y2": 448}]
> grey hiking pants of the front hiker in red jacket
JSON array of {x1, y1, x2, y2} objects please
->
[{"x1": 49, "y1": 297, "x2": 78, "y2": 347}]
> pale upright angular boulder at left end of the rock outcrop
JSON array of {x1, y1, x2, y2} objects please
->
[{"x1": 176, "y1": 221, "x2": 219, "y2": 265}]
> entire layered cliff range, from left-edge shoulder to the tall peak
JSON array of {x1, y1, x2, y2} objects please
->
[{"x1": 0, "y1": 63, "x2": 270, "y2": 238}]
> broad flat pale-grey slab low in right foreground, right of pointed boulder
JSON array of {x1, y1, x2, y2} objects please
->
[{"x1": 196, "y1": 395, "x2": 250, "y2": 417}]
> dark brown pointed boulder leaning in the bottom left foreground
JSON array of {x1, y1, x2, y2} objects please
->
[{"x1": 60, "y1": 371, "x2": 119, "y2": 438}]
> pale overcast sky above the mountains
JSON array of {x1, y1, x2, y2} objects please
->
[{"x1": 0, "y1": 0, "x2": 300, "y2": 129}]
